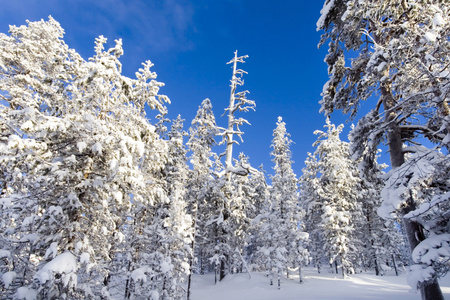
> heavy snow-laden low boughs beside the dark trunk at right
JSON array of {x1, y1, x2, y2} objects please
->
[{"x1": 379, "y1": 146, "x2": 450, "y2": 286}]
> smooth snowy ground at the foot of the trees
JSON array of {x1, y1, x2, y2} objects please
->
[{"x1": 192, "y1": 268, "x2": 450, "y2": 300}]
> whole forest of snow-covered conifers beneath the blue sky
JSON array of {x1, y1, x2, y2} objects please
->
[{"x1": 0, "y1": 0, "x2": 450, "y2": 300}]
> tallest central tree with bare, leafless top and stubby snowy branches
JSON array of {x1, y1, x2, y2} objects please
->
[{"x1": 202, "y1": 51, "x2": 255, "y2": 280}]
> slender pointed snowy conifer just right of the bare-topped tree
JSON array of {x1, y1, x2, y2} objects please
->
[{"x1": 259, "y1": 117, "x2": 309, "y2": 286}]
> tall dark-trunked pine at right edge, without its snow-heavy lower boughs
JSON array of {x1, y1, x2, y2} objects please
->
[{"x1": 317, "y1": 0, "x2": 450, "y2": 299}]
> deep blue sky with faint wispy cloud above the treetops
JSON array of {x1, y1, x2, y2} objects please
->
[{"x1": 0, "y1": 0, "x2": 360, "y2": 176}]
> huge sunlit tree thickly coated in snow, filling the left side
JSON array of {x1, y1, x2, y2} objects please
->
[{"x1": 0, "y1": 18, "x2": 168, "y2": 298}]
